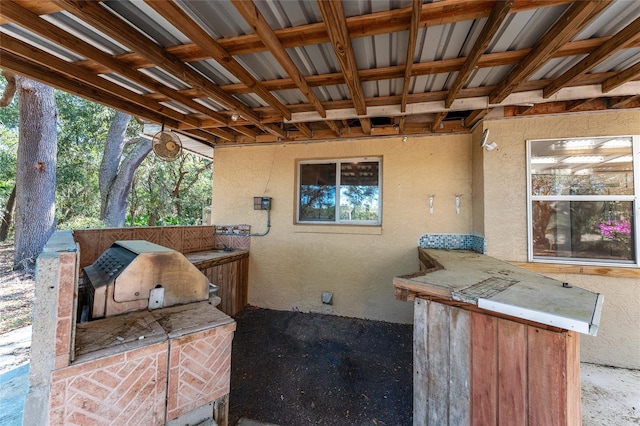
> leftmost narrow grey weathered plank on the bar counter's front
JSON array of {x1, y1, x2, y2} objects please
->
[{"x1": 413, "y1": 297, "x2": 429, "y2": 426}]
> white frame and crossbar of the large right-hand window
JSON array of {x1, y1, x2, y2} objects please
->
[{"x1": 526, "y1": 135, "x2": 640, "y2": 268}]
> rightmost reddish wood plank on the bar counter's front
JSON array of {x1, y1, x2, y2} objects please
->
[{"x1": 527, "y1": 327, "x2": 567, "y2": 426}]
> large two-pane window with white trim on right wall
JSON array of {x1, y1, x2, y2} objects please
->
[{"x1": 527, "y1": 136, "x2": 640, "y2": 267}]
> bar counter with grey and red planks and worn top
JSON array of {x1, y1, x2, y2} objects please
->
[{"x1": 393, "y1": 249, "x2": 603, "y2": 426}]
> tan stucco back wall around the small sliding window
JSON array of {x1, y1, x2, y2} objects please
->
[{"x1": 212, "y1": 135, "x2": 472, "y2": 323}]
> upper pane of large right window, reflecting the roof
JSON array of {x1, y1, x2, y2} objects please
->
[{"x1": 530, "y1": 137, "x2": 634, "y2": 195}]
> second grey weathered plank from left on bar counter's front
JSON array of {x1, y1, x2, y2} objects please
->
[{"x1": 427, "y1": 301, "x2": 451, "y2": 425}]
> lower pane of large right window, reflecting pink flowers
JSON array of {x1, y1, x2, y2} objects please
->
[{"x1": 533, "y1": 201, "x2": 635, "y2": 261}]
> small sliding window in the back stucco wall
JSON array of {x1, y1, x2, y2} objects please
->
[{"x1": 296, "y1": 157, "x2": 382, "y2": 225}]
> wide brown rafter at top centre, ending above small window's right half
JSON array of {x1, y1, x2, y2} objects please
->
[{"x1": 318, "y1": 0, "x2": 367, "y2": 115}]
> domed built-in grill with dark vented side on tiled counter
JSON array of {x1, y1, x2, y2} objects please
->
[{"x1": 78, "y1": 240, "x2": 210, "y2": 322}]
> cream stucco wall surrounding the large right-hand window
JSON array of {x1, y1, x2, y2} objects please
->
[{"x1": 482, "y1": 110, "x2": 640, "y2": 368}]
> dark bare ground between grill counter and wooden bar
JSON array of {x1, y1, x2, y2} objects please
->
[{"x1": 229, "y1": 307, "x2": 413, "y2": 426}]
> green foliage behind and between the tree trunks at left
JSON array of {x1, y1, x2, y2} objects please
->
[{"x1": 0, "y1": 77, "x2": 211, "y2": 229}]
